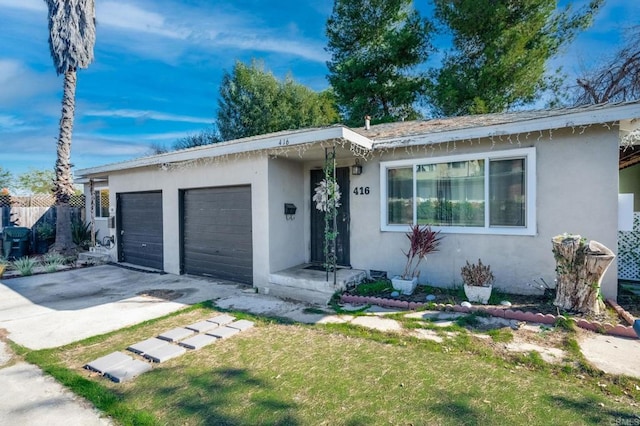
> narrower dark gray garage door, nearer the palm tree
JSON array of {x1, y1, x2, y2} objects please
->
[{"x1": 116, "y1": 191, "x2": 164, "y2": 270}]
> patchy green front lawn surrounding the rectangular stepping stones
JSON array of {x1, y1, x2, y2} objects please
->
[{"x1": 19, "y1": 304, "x2": 640, "y2": 425}]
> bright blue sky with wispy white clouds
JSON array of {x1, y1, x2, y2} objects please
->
[{"x1": 0, "y1": 0, "x2": 640, "y2": 175}]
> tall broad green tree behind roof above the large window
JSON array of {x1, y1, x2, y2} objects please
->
[{"x1": 429, "y1": 0, "x2": 604, "y2": 116}]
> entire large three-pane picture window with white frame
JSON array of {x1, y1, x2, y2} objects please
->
[{"x1": 380, "y1": 148, "x2": 535, "y2": 235}]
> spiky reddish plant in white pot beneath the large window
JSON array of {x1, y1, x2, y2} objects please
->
[{"x1": 391, "y1": 225, "x2": 442, "y2": 295}]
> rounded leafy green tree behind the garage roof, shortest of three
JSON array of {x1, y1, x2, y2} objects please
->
[{"x1": 216, "y1": 61, "x2": 339, "y2": 140}]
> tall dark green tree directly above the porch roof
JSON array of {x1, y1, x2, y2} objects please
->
[{"x1": 326, "y1": 0, "x2": 433, "y2": 125}]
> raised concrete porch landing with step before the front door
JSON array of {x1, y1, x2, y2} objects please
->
[{"x1": 258, "y1": 264, "x2": 367, "y2": 305}]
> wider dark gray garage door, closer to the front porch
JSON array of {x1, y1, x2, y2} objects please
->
[{"x1": 182, "y1": 186, "x2": 253, "y2": 284}]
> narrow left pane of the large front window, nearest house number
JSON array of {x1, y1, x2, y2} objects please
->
[{"x1": 387, "y1": 167, "x2": 413, "y2": 225}]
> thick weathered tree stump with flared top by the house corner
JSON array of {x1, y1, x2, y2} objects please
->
[{"x1": 552, "y1": 234, "x2": 616, "y2": 314}]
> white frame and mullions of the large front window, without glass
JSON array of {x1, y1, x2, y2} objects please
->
[{"x1": 380, "y1": 147, "x2": 537, "y2": 235}]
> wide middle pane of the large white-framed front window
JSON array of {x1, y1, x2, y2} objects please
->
[{"x1": 416, "y1": 160, "x2": 484, "y2": 226}]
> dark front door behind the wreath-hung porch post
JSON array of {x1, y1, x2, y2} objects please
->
[{"x1": 310, "y1": 167, "x2": 351, "y2": 266}]
